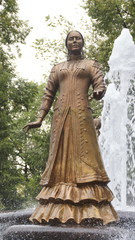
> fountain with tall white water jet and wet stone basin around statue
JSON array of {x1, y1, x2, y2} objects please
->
[{"x1": 0, "y1": 29, "x2": 135, "y2": 240}]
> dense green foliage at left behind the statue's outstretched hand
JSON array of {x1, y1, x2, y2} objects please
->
[{"x1": 0, "y1": 66, "x2": 50, "y2": 209}]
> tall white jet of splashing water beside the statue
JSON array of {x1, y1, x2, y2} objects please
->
[{"x1": 99, "y1": 29, "x2": 135, "y2": 211}]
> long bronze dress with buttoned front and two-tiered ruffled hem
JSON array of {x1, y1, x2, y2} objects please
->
[{"x1": 30, "y1": 59, "x2": 118, "y2": 224}]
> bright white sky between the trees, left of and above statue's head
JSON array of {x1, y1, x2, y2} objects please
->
[{"x1": 16, "y1": 0, "x2": 87, "y2": 82}]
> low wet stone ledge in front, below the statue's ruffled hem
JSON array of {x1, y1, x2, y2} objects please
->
[{"x1": 3, "y1": 225, "x2": 135, "y2": 240}]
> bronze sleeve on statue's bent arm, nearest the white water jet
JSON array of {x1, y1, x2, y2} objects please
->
[{"x1": 92, "y1": 61, "x2": 106, "y2": 100}]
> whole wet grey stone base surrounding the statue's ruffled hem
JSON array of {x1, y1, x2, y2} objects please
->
[{"x1": 0, "y1": 211, "x2": 135, "y2": 240}]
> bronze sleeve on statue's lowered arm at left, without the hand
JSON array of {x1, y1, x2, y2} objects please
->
[{"x1": 40, "y1": 67, "x2": 58, "y2": 113}]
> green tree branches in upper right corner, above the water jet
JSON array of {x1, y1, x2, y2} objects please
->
[{"x1": 84, "y1": 0, "x2": 135, "y2": 70}]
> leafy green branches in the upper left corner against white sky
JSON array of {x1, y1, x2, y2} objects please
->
[{"x1": 0, "y1": 0, "x2": 29, "y2": 45}]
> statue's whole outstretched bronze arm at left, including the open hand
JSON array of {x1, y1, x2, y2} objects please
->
[{"x1": 23, "y1": 67, "x2": 58, "y2": 132}]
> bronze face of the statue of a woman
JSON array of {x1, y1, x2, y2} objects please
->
[{"x1": 67, "y1": 31, "x2": 83, "y2": 53}]
